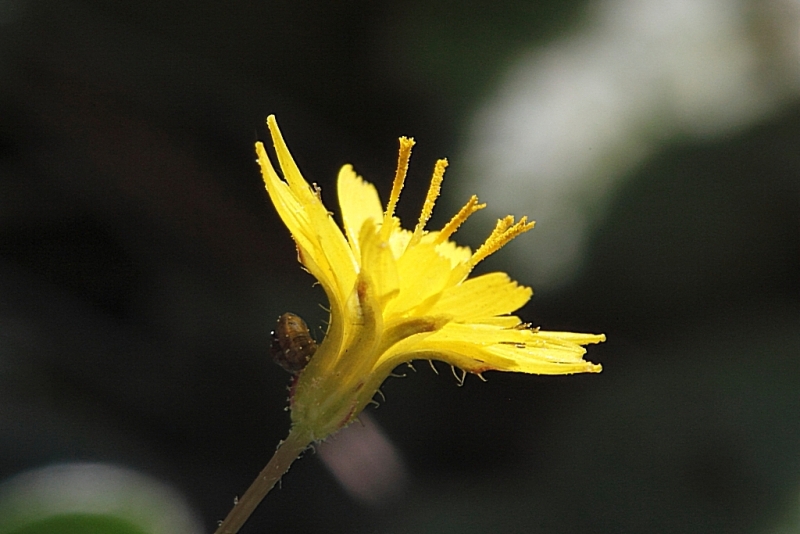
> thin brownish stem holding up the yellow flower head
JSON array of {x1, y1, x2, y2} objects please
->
[{"x1": 214, "y1": 427, "x2": 311, "y2": 534}]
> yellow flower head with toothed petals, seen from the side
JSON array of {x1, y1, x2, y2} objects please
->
[{"x1": 256, "y1": 116, "x2": 605, "y2": 440}]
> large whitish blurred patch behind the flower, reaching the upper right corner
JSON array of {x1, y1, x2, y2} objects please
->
[{"x1": 456, "y1": 0, "x2": 800, "y2": 287}]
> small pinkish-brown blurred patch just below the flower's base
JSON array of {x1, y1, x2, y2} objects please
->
[{"x1": 317, "y1": 412, "x2": 408, "y2": 505}]
